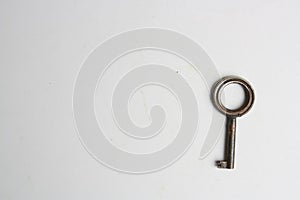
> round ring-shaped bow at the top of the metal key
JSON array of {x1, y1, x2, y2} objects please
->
[{"x1": 212, "y1": 76, "x2": 254, "y2": 117}]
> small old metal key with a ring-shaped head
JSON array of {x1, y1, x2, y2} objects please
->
[{"x1": 212, "y1": 76, "x2": 254, "y2": 169}]
